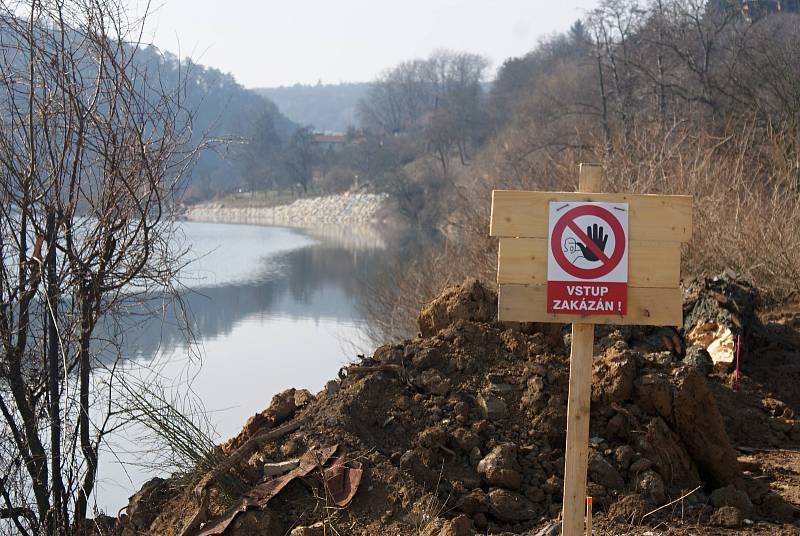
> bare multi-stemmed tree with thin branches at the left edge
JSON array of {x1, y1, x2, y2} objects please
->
[{"x1": 0, "y1": 0, "x2": 191, "y2": 535}]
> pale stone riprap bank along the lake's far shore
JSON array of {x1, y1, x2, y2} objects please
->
[{"x1": 186, "y1": 192, "x2": 388, "y2": 228}]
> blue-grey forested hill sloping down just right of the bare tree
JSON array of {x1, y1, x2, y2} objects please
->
[{"x1": 136, "y1": 47, "x2": 297, "y2": 202}]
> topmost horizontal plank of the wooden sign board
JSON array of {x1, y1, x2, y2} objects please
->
[{"x1": 489, "y1": 190, "x2": 692, "y2": 242}]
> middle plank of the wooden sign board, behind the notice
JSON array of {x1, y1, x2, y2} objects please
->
[{"x1": 497, "y1": 238, "x2": 681, "y2": 288}]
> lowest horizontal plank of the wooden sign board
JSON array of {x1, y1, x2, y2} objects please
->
[{"x1": 497, "y1": 284, "x2": 683, "y2": 326}]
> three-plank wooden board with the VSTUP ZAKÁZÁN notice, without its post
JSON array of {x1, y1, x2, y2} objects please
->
[{"x1": 490, "y1": 186, "x2": 692, "y2": 326}]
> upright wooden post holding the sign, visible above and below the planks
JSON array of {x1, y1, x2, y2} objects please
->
[{"x1": 561, "y1": 164, "x2": 602, "y2": 536}]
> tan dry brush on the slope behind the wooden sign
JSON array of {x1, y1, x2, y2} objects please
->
[{"x1": 451, "y1": 123, "x2": 800, "y2": 302}]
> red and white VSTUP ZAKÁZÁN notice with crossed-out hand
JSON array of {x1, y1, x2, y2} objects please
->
[{"x1": 547, "y1": 201, "x2": 628, "y2": 315}]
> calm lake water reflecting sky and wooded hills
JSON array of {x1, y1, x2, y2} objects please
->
[{"x1": 97, "y1": 222, "x2": 402, "y2": 512}]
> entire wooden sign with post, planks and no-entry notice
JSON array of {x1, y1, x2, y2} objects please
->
[{"x1": 490, "y1": 164, "x2": 692, "y2": 536}]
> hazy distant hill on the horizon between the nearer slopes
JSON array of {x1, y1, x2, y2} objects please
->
[{"x1": 253, "y1": 82, "x2": 371, "y2": 132}]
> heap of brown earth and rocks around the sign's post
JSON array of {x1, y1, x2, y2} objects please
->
[{"x1": 108, "y1": 280, "x2": 800, "y2": 536}]
